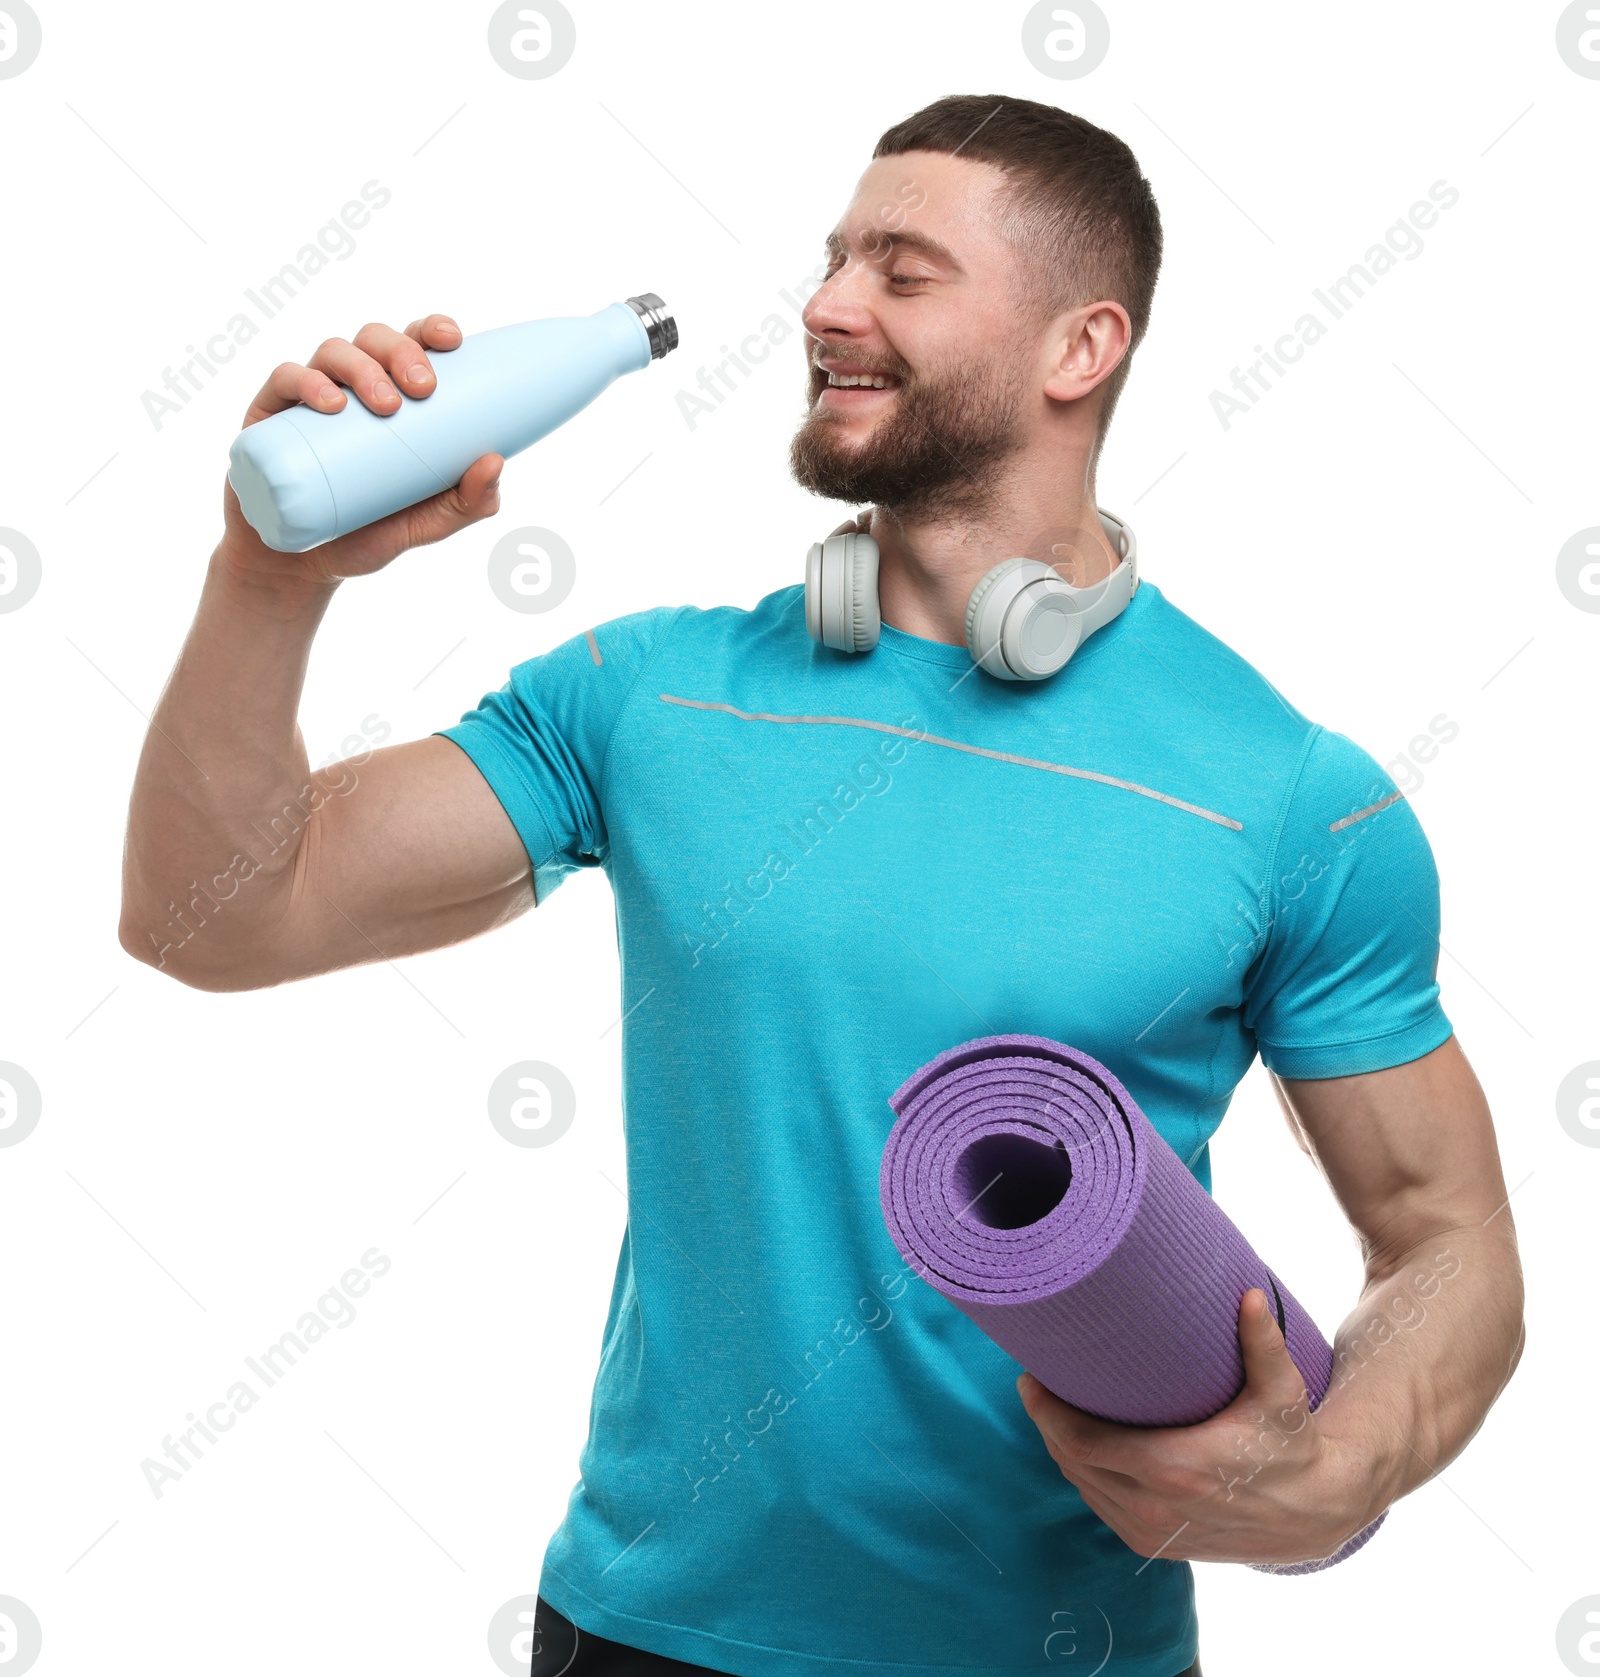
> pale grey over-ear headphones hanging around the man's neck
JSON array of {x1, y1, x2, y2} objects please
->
[{"x1": 805, "y1": 506, "x2": 1139, "y2": 681}]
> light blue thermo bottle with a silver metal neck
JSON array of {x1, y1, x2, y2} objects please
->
[{"x1": 228, "y1": 292, "x2": 678, "y2": 553}]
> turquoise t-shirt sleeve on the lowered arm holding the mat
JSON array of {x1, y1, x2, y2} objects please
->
[{"x1": 1244, "y1": 728, "x2": 1451, "y2": 1078}]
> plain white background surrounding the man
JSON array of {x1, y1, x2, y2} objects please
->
[{"x1": 0, "y1": 0, "x2": 1600, "y2": 1677}]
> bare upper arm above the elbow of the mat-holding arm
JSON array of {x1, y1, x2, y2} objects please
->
[{"x1": 1276, "y1": 1036, "x2": 1506, "y2": 1263}]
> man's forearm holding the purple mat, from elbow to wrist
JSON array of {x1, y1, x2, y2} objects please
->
[{"x1": 1318, "y1": 1212, "x2": 1523, "y2": 1518}]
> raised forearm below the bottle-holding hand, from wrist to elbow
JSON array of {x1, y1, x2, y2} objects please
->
[{"x1": 119, "y1": 547, "x2": 337, "y2": 988}]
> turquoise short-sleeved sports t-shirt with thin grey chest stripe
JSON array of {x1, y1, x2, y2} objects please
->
[{"x1": 444, "y1": 582, "x2": 1451, "y2": 1677}]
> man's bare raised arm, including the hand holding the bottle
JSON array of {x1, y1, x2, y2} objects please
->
[{"x1": 119, "y1": 315, "x2": 533, "y2": 989}]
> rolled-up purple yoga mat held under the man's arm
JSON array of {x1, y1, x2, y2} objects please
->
[{"x1": 879, "y1": 1036, "x2": 1385, "y2": 1575}]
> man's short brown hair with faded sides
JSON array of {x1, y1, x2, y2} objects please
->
[{"x1": 872, "y1": 94, "x2": 1161, "y2": 438}]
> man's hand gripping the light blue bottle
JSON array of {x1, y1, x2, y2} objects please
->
[{"x1": 218, "y1": 314, "x2": 505, "y2": 589}]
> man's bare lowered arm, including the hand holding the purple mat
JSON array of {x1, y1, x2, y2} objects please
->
[{"x1": 1018, "y1": 1036, "x2": 1523, "y2": 1561}]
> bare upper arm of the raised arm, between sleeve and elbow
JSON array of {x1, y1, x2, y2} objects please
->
[{"x1": 273, "y1": 735, "x2": 533, "y2": 978}]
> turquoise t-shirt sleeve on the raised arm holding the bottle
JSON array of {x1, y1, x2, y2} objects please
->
[{"x1": 438, "y1": 607, "x2": 678, "y2": 902}]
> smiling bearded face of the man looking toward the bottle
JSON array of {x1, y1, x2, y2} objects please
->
[{"x1": 790, "y1": 151, "x2": 1043, "y2": 517}]
